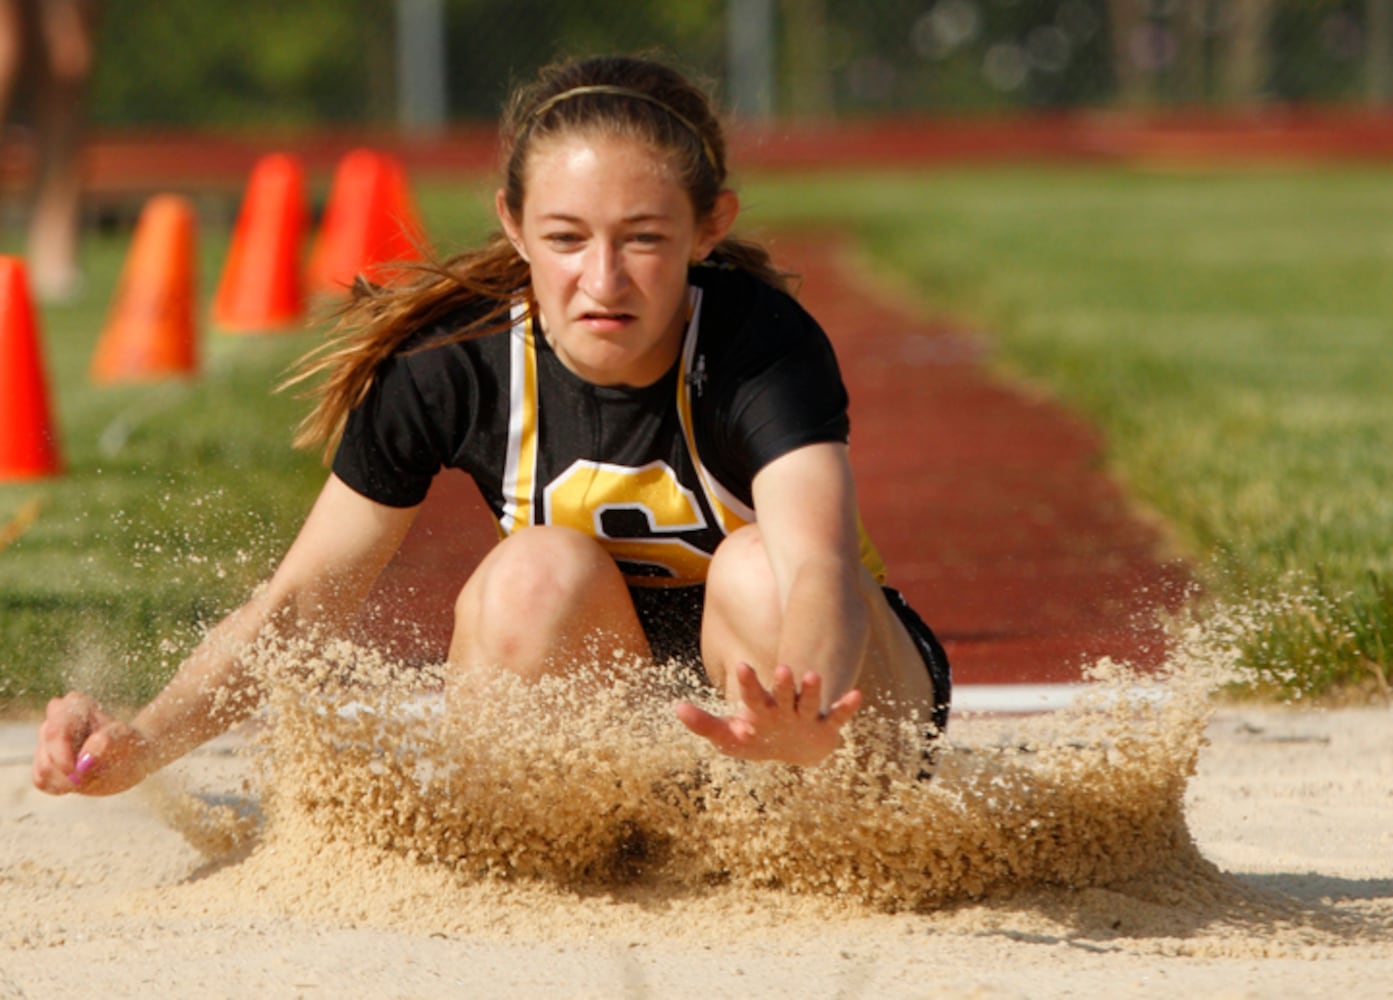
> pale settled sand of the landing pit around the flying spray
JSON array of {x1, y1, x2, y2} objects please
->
[{"x1": 0, "y1": 696, "x2": 1393, "y2": 999}]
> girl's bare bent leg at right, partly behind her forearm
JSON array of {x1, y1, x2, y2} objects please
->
[{"x1": 702, "y1": 525, "x2": 935, "y2": 720}]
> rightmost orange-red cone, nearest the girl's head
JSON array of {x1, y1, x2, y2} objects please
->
[{"x1": 305, "y1": 149, "x2": 422, "y2": 295}]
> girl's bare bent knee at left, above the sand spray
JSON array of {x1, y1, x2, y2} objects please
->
[{"x1": 450, "y1": 526, "x2": 651, "y2": 704}]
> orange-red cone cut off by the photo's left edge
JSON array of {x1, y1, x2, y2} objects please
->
[{"x1": 0, "y1": 256, "x2": 63, "y2": 479}]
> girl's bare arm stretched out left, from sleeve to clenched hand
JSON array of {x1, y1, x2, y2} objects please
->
[{"x1": 33, "y1": 476, "x2": 417, "y2": 794}]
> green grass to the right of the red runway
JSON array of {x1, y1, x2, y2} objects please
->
[{"x1": 745, "y1": 169, "x2": 1393, "y2": 692}]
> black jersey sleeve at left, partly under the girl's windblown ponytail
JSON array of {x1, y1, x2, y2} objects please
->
[{"x1": 333, "y1": 354, "x2": 449, "y2": 507}]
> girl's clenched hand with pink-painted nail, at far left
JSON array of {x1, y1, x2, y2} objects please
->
[{"x1": 33, "y1": 691, "x2": 152, "y2": 795}]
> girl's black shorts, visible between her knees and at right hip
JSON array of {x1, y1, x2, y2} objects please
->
[{"x1": 628, "y1": 585, "x2": 953, "y2": 733}]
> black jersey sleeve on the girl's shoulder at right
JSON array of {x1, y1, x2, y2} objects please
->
[{"x1": 712, "y1": 278, "x2": 850, "y2": 494}]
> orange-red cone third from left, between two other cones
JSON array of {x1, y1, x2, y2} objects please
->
[{"x1": 213, "y1": 153, "x2": 309, "y2": 333}]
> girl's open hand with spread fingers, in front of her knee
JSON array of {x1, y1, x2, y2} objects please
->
[{"x1": 676, "y1": 663, "x2": 861, "y2": 767}]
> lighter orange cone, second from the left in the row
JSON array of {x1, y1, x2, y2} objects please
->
[{"x1": 92, "y1": 195, "x2": 198, "y2": 382}]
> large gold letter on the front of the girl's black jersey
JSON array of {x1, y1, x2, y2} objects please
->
[{"x1": 543, "y1": 460, "x2": 710, "y2": 582}]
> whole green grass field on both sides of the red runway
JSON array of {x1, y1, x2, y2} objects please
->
[{"x1": 0, "y1": 169, "x2": 1393, "y2": 706}]
